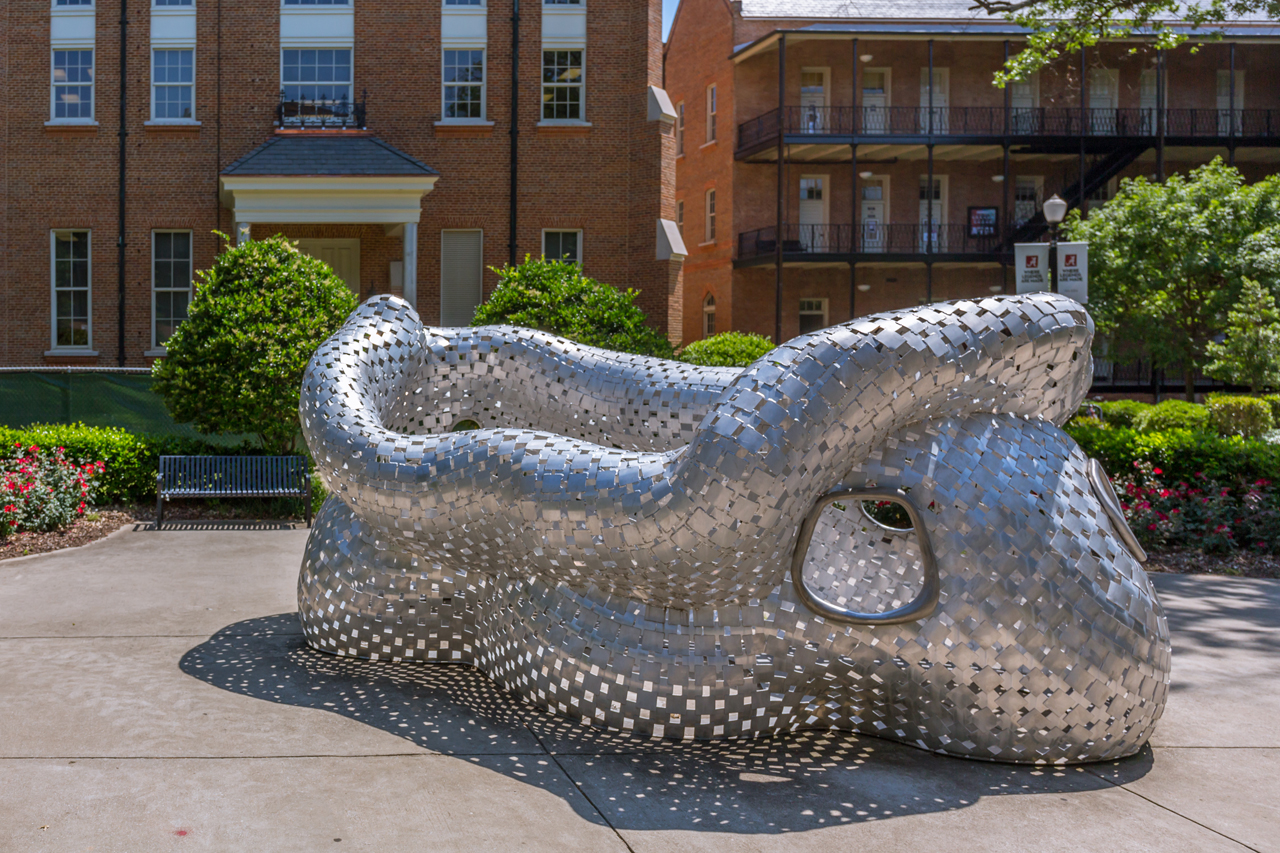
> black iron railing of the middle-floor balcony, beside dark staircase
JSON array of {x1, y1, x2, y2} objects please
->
[{"x1": 737, "y1": 223, "x2": 1001, "y2": 260}]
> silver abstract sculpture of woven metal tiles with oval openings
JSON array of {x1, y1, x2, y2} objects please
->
[{"x1": 298, "y1": 293, "x2": 1170, "y2": 763}]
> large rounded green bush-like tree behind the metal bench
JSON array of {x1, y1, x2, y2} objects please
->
[{"x1": 152, "y1": 234, "x2": 356, "y2": 452}]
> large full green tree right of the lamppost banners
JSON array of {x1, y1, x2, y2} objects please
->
[{"x1": 1066, "y1": 159, "x2": 1280, "y2": 400}]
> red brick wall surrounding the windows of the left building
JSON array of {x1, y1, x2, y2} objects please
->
[{"x1": 0, "y1": 0, "x2": 680, "y2": 365}]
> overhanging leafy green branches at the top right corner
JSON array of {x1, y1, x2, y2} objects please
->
[{"x1": 972, "y1": 0, "x2": 1280, "y2": 86}]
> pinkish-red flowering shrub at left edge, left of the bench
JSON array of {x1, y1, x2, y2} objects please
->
[{"x1": 0, "y1": 443, "x2": 106, "y2": 539}]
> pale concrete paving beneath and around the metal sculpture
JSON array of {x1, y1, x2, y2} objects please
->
[{"x1": 0, "y1": 523, "x2": 1280, "y2": 853}]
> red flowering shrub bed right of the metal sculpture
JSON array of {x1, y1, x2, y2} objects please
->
[{"x1": 1116, "y1": 461, "x2": 1280, "y2": 553}]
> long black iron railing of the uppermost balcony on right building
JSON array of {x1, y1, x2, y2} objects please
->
[{"x1": 737, "y1": 106, "x2": 1280, "y2": 149}]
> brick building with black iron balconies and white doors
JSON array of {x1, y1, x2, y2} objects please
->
[{"x1": 664, "y1": 0, "x2": 1280, "y2": 342}]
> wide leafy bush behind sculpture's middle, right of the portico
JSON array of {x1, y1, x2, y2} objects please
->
[{"x1": 471, "y1": 256, "x2": 672, "y2": 359}]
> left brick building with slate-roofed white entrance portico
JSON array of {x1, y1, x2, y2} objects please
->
[{"x1": 0, "y1": 0, "x2": 684, "y2": 366}]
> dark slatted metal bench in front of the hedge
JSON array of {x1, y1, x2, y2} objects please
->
[{"x1": 156, "y1": 456, "x2": 311, "y2": 530}]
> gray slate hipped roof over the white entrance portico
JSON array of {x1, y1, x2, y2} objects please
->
[{"x1": 223, "y1": 133, "x2": 439, "y2": 175}]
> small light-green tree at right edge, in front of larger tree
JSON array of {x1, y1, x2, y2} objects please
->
[{"x1": 1204, "y1": 278, "x2": 1280, "y2": 393}]
